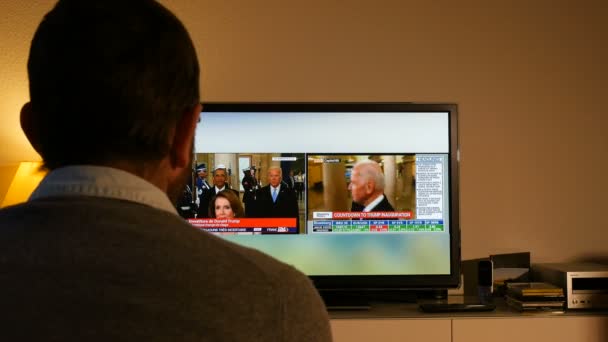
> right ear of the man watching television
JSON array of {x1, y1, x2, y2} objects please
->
[{"x1": 170, "y1": 103, "x2": 202, "y2": 168}]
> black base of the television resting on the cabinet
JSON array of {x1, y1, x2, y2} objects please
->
[{"x1": 319, "y1": 289, "x2": 448, "y2": 310}]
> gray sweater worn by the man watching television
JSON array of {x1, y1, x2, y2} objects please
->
[{"x1": 0, "y1": 196, "x2": 331, "y2": 342}]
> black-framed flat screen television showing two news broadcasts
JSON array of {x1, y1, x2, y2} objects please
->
[{"x1": 180, "y1": 102, "x2": 460, "y2": 304}]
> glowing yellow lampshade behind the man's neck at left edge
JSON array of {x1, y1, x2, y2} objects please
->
[{"x1": 0, "y1": 162, "x2": 47, "y2": 208}]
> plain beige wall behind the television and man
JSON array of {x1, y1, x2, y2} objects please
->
[{"x1": 0, "y1": 0, "x2": 608, "y2": 262}]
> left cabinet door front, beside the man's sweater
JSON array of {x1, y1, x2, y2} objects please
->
[{"x1": 331, "y1": 318, "x2": 452, "y2": 342}]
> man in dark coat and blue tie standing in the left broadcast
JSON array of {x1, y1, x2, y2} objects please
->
[{"x1": 255, "y1": 166, "x2": 300, "y2": 227}]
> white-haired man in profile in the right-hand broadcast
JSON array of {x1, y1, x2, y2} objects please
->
[{"x1": 348, "y1": 160, "x2": 395, "y2": 212}]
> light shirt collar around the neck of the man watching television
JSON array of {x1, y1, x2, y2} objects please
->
[{"x1": 29, "y1": 165, "x2": 177, "y2": 215}]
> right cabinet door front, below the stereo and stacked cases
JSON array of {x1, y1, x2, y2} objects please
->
[{"x1": 452, "y1": 316, "x2": 608, "y2": 342}]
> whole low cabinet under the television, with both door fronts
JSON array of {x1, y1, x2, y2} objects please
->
[{"x1": 331, "y1": 304, "x2": 608, "y2": 342}]
